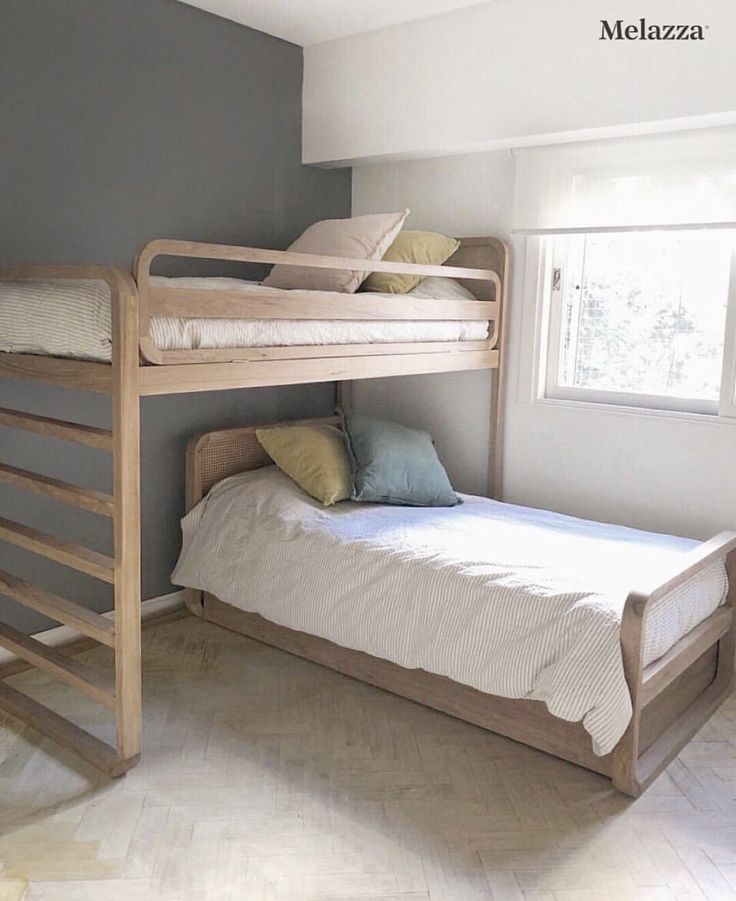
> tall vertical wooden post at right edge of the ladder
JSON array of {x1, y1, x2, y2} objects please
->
[{"x1": 112, "y1": 274, "x2": 142, "y2": 770}]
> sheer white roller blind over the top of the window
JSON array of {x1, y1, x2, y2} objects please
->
[{"x1": 514, "y1": 128, "x2": 736, "y2": 234}]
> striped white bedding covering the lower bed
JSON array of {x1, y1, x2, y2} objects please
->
[{"x1": 173, "y1": 467, "x2": 727, "y2": 755}]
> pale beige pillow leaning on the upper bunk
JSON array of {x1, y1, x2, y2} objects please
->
[{"x1": 263, "y1": 210, "x2": 409, "y2": 294}]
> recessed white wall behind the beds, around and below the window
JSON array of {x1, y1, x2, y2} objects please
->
[{"x1": 353, "y1": 151, "x2": 736, "y2": 538}]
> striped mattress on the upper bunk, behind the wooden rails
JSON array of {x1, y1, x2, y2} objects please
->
[{"x1": 0, "y1": 277, "x2": 488, "y2": 362}]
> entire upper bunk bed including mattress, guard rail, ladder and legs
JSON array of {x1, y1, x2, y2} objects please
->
[{"x1": 0, "y1": 232, "x2": 507, "y2": 776}]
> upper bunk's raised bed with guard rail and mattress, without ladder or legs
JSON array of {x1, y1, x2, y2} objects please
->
[{"x1": 0, "y1": 237, "x2": 508, "y2": 396}]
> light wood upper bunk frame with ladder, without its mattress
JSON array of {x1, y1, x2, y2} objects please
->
[{"x1": 0, "y1": 237, "x2": 508, "y2": 776}]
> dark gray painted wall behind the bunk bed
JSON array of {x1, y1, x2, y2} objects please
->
[{"x1": 0, "y1": 0, "x2": 350, "y2": 631}]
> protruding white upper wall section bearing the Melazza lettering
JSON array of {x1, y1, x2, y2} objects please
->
[{"x1": 303, "y1": 0, "x2": 736, "y2": 163}]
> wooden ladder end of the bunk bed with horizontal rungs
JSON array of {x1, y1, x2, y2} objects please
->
[{"x1": 0, "y1": 266, "x2": 141, "y2": 776}]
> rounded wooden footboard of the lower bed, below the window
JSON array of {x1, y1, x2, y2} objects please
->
[{"x1": 613, "y1": 532, "x2": 736, "y2": 797}]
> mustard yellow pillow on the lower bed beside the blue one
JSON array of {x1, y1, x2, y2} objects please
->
[{"x1": 256, "y1": 425, "x2": 353, "y2": 507}]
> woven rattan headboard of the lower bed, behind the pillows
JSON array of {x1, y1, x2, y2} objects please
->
[{"x1": 187, "y1": 416, "x2": 340, "y2": 510}]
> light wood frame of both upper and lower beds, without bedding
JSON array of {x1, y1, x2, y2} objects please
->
[{"x1": 0, "y1": 238, "x2": 736, "y2": 796}]
